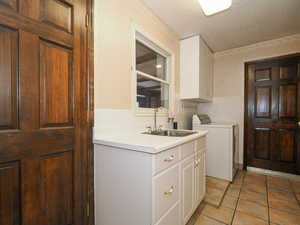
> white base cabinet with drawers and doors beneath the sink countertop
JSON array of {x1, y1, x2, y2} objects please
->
[{"x1": 95, "y1": 136, "x2": 206, "y2": 225}]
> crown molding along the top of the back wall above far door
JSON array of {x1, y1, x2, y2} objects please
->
[{"x1": 214, "y1": 34, "x2": 300, "y2": 58}]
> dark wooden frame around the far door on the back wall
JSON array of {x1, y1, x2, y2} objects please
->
[{"x1": 243, "y1": 53, "x2": 300, "y2": 170}]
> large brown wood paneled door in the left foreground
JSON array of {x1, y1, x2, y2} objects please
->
[{"x1": 0, "y1": 0, "x2": 90, "y2": 225}]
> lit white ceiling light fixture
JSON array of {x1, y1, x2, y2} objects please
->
[{"x1": 198, "y1": 0, "x2": 232, "y2": 16}]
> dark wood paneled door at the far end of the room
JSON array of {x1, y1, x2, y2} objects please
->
[{"x1": 245, "y1": 56, "x2": 300, "y2": 174}]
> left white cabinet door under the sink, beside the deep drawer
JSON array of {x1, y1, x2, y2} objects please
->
[{"x1": 181, "y1": 155, "x2": 195, "y2": 224}]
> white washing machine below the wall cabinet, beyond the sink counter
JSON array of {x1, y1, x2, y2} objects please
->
[{"x1": 193, "y1": 116, "x2": 239, "y2": 182}]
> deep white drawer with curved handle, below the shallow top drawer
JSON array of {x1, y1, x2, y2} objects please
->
[{"x1": 153, "y1": 165, "x2": 179, "y2": 223}]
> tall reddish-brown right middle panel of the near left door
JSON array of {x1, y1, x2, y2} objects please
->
[{"x1": 40, "y1": 41, "x2": 74, "y2": 127}]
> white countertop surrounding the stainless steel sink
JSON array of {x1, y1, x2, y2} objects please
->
[{"x1": 94, "y1": 131, "x2": 208, "y2": 154}]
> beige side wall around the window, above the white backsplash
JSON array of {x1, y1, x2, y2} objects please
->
[{"x1": 95, "y1": 0, "x2": 179, "y2": 109}]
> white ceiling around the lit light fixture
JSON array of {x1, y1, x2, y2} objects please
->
[{"x1": 143, "y1": 0, "x2": 300, "y2": 52}]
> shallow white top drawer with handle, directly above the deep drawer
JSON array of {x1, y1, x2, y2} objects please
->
[{"x1": 153, "y1": 147, "x2": 180, "y2": 174}]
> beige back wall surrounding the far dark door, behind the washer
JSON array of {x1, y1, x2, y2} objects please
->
[{"x1": 198, "y1": 35, "x2": 300, "y2": 163}]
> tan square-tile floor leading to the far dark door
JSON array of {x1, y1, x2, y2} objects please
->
[{"x1": 188, "y1": 171, "x2": 300, "y2": 225}]
